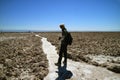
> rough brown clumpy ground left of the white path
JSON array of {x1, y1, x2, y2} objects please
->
[{"x1": 0, "y1": 33, "x2": 48, "y2": 80}]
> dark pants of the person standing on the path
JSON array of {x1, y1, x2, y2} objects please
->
[{"x1": 58, "y1": 44, "x2": 67, "y2": 64}]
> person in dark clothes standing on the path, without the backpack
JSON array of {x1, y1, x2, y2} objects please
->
[{"x1": 55, "y1": 24, "x2": 68, "y2": 66}]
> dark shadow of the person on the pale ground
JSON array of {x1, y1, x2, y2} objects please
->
[{"x1": 55, "y1": 65, "x2": 73, "y2": 80}]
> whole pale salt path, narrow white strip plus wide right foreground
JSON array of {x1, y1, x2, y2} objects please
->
[{"x1": 38, "y1": 37, "x2": 120, "y2": 80}]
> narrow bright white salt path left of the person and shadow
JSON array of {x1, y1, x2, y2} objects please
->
[{"x1": 41, "y1": 38, "x2": 58, "y2": 80}]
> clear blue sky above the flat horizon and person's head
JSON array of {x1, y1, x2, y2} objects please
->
[{"x1": 0, "y1": 0, "x2": 120, "y2": 31}]
